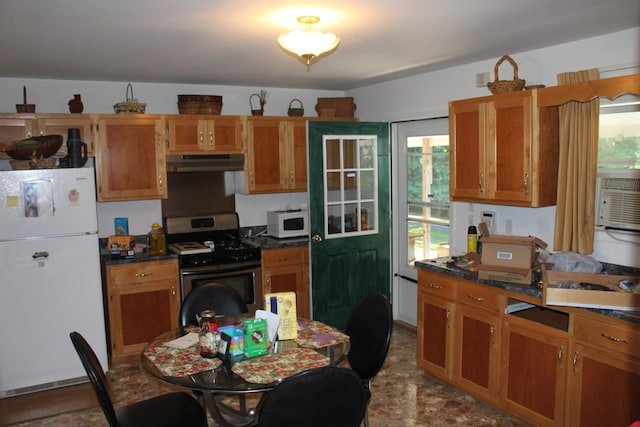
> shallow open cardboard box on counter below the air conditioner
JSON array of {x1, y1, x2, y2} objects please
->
[{"x1": 542, "y1": 267, "x2": 640, "y2": 311}]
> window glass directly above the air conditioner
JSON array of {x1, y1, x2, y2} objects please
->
[{"x1": 598, "y1": 96, "x2": 640, "y2": 169}]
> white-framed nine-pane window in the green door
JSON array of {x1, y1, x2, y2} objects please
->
[{"x1": 323, "y1": 135, "x2": 378, "y2": 238}]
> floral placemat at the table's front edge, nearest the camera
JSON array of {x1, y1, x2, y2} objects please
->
[{"x1": 231, "y1": 348, "x2": 330, "y2": 384}]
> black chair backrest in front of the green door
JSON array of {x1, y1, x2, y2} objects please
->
[{"x1": 345, "y1": 294, "x2": 393, "y2": 380}]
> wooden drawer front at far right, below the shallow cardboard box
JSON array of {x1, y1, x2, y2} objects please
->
[{"x1": 573, "y1": 316, "x2": 640, "y2": 357}]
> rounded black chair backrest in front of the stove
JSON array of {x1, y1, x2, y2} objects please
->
[{"x1": 178, "y1": 282, "x2": 249, "y2": 326}]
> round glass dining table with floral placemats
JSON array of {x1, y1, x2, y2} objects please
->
[{"x1": 140, "y1": 316, "x2": 350, "y2": 427}]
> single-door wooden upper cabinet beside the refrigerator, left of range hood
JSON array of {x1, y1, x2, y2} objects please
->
[{"x1": 96, "y1": 114, "x2": 167, "y2": 201}]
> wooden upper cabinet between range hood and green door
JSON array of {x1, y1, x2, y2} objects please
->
[{"x1": 243, "y1": 117, "x2": 307, "y2": 193}]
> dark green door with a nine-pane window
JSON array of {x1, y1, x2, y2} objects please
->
[{"x1": 309, "y1": 122, "x2": 391, "y2": 329}]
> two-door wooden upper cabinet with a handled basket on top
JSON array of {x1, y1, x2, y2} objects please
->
[{"x1": 449, "y1": 91, "x2": 559, "y2": 207}]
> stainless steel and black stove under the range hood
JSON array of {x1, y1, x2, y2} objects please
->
[{"x1": 164, "y1": 212, "x2": 264, "y2": 313}]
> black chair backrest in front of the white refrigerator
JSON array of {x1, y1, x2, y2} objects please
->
[{"x1": 69, "y1": 332, "x2": 118, "y2": 427}]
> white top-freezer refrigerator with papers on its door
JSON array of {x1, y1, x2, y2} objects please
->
[{"x1": 0, "y1": 167, "x2": 108, "y2": 398}]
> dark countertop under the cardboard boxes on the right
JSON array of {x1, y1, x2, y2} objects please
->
[{"x1": 414, "y1": 257, "x2": 640, "y2": 325}]
